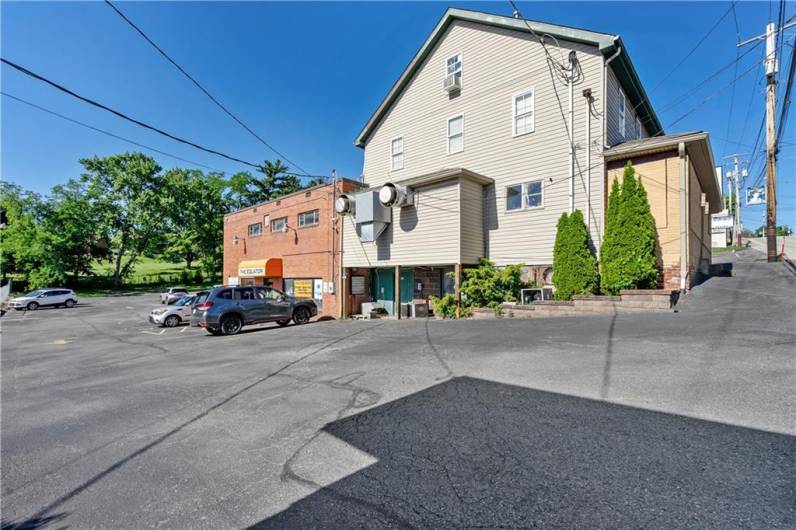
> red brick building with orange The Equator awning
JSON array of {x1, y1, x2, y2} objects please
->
[{"x1": 223, "y1": 179, "x2": 362, "y2": 317}]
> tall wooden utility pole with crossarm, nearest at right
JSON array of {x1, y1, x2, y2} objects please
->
[{"x1": 738, "y1": 21, "x2": 796, "y2": 262}]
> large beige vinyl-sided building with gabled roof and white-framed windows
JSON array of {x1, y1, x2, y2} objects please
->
[{"x1": 342, "y1": 9, "x2": 715, "y2": 312}]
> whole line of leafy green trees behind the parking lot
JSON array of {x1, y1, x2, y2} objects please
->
[{"x1": 0, "y1": 153, "x2": 321, "y2": 287}]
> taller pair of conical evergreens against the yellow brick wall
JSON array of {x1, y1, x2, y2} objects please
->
[{"x1": 600, "y1": 161, "x2": 659, "y2": 294}]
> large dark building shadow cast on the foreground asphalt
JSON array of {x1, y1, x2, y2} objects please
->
[{"x1": 252, "y1": 377, "x2": 796, "y2": 529}]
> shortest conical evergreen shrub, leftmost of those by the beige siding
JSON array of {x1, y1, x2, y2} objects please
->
[{"x1": 553, "y1": 210, "x2": 599, "y2": 300}]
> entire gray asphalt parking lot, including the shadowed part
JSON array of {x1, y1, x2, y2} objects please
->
[{"x1": 0, "y1": 251, "x2": 796, "y2": 529}]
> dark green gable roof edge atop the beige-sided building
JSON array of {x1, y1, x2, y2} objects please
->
[{"x1": 354, "y1": 8, "x2": 663, "y2": 147}]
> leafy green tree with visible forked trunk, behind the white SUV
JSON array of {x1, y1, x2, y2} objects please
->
[{"x1": 80, "y1": 153, "x2": 164, "y2": 287}]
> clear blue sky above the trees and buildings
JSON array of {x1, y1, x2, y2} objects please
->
[{"x1": 0, "y1": 2, "x2": 796, "y2": 228}]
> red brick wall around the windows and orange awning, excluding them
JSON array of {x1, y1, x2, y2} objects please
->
[{"x1": 223, "y1": 180, "x2": 360, "y2": 317}]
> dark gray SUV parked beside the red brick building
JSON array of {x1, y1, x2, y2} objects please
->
[{"x1": 191, "y1": 286, "x2": 318, "y2": 335}]
